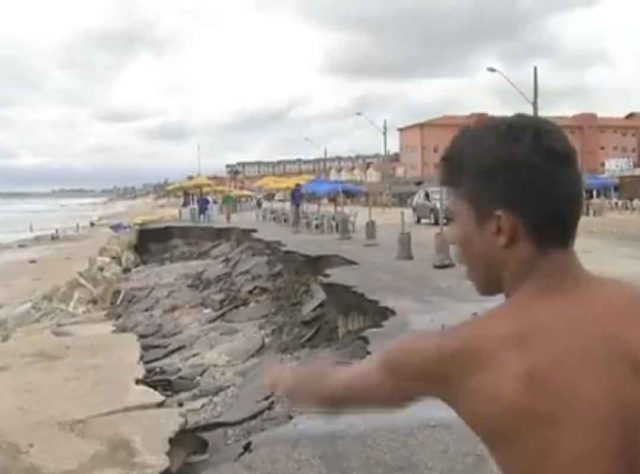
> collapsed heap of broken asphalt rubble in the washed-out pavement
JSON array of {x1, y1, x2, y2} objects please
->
[{"x1": 113, "y1": 227, "x2": 392, "y2": 472}]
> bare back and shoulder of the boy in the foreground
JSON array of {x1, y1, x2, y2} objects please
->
[{"x1": 458, "y1": 276, "x2": 640, "y2": 473}]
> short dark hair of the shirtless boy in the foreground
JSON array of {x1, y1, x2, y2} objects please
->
[{"x1": 440, "y1": 115, "x2": 583, "y2": 250}]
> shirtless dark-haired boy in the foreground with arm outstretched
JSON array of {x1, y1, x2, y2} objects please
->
[{"x1": 265, "y1": 115, "x2": 640, "y2": 474}]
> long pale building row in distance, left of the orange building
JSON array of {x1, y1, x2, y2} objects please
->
[{"x1": 225, "y1": 153, "x2": 399, "y2": 181}]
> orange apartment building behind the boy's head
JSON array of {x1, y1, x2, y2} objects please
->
[{"x1": 398, "y1": 112, "x2": 640, "y2": 179}]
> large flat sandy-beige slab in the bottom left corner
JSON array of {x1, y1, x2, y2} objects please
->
[{"x1": 0, "y1": 322, "x2": 182, "y2": 474}]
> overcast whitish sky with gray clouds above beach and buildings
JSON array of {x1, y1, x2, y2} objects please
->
[{"x1": 0, "y1": 0, "x2": 640, "y2": 189}]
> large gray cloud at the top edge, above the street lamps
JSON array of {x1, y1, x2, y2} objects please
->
[{"x1": 284, "y1": 0, "x2": 596, "y2": 79}]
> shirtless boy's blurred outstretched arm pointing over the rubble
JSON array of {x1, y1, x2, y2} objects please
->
[{"x1": 265, "y1": 324, "x2": 475, "y2": 408}]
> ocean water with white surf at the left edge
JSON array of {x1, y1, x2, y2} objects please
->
[{"x1": 0, "y1": 194, "x2": 106, "y2": 243}]
